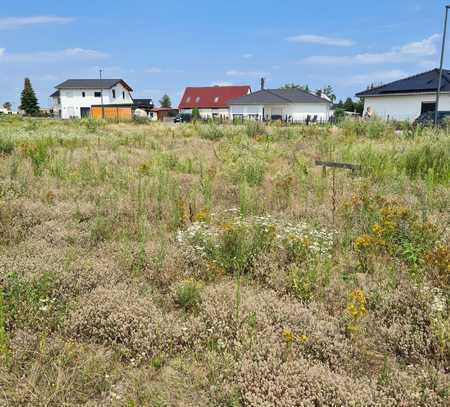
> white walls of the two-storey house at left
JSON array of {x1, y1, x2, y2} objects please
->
[{"x1": 60, "y1": 83, "x2": 133, "y2": 119}]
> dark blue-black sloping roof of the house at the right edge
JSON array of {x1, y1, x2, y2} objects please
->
[{"x1": 356, "y1": 69, "x2": 450, "y2": 97}]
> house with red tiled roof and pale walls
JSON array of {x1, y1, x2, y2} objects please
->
[{"x1": 178, "y1": 85, "x2": 251, "y2": 119}]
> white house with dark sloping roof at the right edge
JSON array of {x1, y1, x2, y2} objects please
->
[{"x1": 356, "y1": 69, "x2": 450, "y2": 121}]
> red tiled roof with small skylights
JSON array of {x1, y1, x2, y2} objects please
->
[{"x1": 178, "y1": 86, "x2": 251, "y2": 109}]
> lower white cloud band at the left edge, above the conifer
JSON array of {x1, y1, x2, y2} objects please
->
[{"x1": 0, "y1": 48, "x2": 108, "y2": 64}]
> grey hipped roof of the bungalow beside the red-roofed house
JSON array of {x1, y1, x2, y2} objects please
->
[{"x1": 230, "y1": 89, "x2": 330, "y2": 105}]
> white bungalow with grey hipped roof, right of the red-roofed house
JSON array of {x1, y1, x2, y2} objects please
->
[{"x1": 229, "y1": 89, "x2": 332, "y2": 122}]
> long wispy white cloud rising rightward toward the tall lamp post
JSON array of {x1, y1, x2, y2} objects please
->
[{"x1": 300, "y1": 34, "x2": 440, "y2": 65}]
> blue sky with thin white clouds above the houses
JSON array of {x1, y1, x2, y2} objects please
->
[{"x1": 0, "y1": 0, "x2": 450, "y2": 107}]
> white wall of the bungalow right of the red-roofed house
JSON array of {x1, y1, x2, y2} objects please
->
[{"x1": 230, "y1": 103, "x2": 330, "y2": 121}]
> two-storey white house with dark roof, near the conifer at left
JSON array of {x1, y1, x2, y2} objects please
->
[{"x1": 50, "y1": 79, "x2": 133, "y2": 119}]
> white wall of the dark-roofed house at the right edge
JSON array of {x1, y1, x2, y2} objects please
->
[{"x1": 364, "y1": 93, "x2": 450, "y2": 121}]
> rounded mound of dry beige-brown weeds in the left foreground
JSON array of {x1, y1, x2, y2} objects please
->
[{"x1": 65, "y1": 286, "x2": 190, "y2": 360}]
